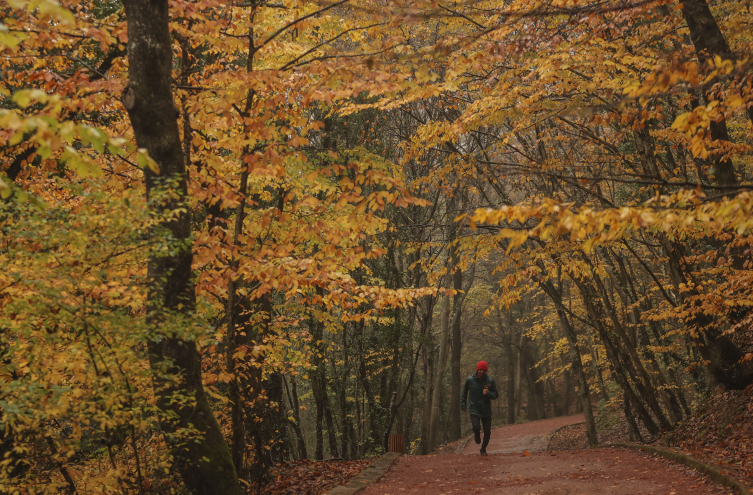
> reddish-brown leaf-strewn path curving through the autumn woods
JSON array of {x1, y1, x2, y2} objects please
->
[{"x1": 361, "y1": 415, "x2": 730, "y2": 495}]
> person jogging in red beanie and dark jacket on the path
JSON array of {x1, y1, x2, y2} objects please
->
[{"x1": 460, "y1": 361, "x2": 499, "y2": 455}]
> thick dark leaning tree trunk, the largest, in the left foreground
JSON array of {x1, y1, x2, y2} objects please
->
[{"x1": 122, "y1": 0, "x2": 241, "y2": 495}]
